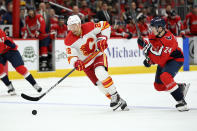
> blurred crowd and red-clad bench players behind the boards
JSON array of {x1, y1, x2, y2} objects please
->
[{"x1": 0, "y1": 0, "x2": 197, "y2": 39}]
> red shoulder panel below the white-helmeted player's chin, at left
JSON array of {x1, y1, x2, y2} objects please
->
[{"x1": 64, "y1": 31, "x2": 79, "y2": 46}]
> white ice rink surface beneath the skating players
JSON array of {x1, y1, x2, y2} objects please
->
[{"x1": 0, "y1": 71, "x2": 197, "y2": 131}]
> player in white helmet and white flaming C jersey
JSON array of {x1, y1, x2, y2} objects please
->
[{"x1": 65, "y1": 15, "x2": 128, "y2": 110}]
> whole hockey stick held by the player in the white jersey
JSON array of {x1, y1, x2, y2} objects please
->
[{"x1": 21, "y1": 51, "x2": 99, "y2": 101}]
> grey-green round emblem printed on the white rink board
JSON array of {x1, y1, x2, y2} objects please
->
[{"x1": 22, "y1": 46, "x2": 37, "y2": 62}]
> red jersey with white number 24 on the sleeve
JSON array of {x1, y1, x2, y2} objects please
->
[{"x1": 148, "y1": 30, "x2": 184, "y2": 67}]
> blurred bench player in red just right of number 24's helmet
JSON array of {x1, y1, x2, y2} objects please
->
[{"x1": 164, "y1": 10, "x2": 185, "y2": 36}]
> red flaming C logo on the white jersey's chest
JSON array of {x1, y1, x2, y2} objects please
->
[{"x1": 80, "y1": 38, "x2": 95, "y2": 56}]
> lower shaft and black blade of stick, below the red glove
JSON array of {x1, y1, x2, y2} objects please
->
[{"x1": 21, "y1": 68, "x2": 76, "y2": 101}]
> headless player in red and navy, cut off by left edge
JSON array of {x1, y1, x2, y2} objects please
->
[{"x1": 0, "y1": 29, "x2": 42, "y2": 95}]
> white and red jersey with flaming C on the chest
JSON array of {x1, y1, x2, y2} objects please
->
[{"x1": 64, "y1": 21, "x2": 111, "y2": 67}]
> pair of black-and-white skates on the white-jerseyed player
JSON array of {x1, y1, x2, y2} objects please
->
[{"x1": 110, "y1": 92, "x2": 129, "y2": 111}]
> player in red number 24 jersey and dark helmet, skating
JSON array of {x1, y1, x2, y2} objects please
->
[{"x1": 138, "y1": 17, "x2": 189, "y2": 111}]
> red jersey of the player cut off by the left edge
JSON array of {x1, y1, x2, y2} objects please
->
[{"x1": 0, "y1": 29, "x2": 17, "y2": 54}]
